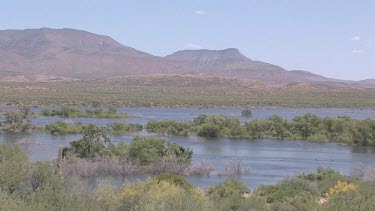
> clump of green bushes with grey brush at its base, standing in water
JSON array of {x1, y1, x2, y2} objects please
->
[{"x1": 60, "y1": 124, "x2": 193, "y2": 176}]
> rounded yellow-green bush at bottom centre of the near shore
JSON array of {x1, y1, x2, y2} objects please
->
[{"x1": 110, "y1": 179, "x2": 207, "y2": 211}]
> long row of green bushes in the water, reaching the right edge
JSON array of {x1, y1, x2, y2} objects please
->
[{"x1": 145, "y1": 114, "x2": 375, "y2": 146}]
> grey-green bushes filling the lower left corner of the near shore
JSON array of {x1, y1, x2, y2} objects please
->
[{"x1": 0, "y1": 145, "x2": 103, "y2": 211}]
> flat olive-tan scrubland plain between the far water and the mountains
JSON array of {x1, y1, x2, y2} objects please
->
[{"x1": 0, "y1": 75, "x2": 375, "y2": 108}]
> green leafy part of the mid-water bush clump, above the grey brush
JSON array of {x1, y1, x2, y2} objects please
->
[{"x1": 63, "y1": 124, "x2": 193, "y2": 169}]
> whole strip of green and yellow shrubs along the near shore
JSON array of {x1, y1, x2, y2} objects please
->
[{"x1": 0, "y1": 143, "x2": 375, "y2": 211}]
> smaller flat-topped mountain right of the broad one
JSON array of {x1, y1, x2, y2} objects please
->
[{"x1": 165, "y1": 48, "x2": 325, "y2": 84}]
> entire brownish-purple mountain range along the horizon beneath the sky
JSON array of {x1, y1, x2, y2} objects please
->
[{"x1": 0, "y1": 28, "x2": 375, "y2": 87}]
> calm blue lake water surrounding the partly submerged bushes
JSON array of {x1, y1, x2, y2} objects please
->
[{"x1": 0, "y1": 108, "x2": 375, "y2": 188}]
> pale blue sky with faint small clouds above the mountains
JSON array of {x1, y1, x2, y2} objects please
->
[{"x1": 0, "y1": 0, "x2": 375, "y2": 80}]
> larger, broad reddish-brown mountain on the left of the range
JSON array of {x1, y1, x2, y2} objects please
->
[{"x1": 0, "y1": 28, "x2": 192, "y2": 79}]
